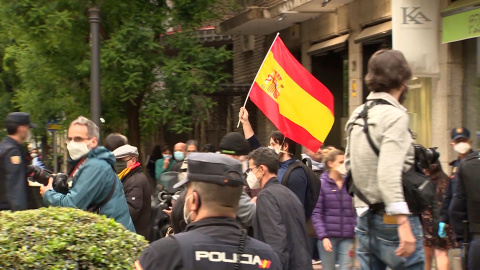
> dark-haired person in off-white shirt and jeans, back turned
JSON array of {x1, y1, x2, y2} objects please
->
[{"x1": 345, "y1": 50, "x2": 425, "y2": 270}]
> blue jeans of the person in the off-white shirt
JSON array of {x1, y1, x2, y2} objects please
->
[{"x1": 355, "y1": 212, "x2": 425, "y2": 270}]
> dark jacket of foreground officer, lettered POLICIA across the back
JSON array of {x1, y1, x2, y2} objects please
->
[{"x1": 139, "y1": 217, "x2": 281, "y2": 270}]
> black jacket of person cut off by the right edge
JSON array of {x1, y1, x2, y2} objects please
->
[{"x1": 450, "y1": 151, "x2": 480, "y2": 234}]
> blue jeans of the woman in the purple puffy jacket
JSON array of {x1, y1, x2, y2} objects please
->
[{"x1": 317, "y1": 238, "x2": 353, "y2": 270}]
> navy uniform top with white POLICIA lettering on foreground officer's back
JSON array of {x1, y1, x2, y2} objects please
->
[{"x1": 139, "y1": 217, "x2": 281, "y2": 270}]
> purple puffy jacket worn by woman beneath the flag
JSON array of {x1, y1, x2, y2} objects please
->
[{"x1": 312, "y1": 171, "x2": 357, "y2": 240}]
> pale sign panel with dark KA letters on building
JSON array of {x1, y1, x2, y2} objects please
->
[{"x1": 392, "y1": 0, "x2": 440, "y2": 77}]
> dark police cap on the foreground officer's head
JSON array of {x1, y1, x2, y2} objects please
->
[{"x1": 173, "y1": 152, "x2": 244, "y2": 188}]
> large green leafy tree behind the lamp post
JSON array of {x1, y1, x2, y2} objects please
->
[{"x1": 0, "y1": 0, "x2": 231, "y2": 151}]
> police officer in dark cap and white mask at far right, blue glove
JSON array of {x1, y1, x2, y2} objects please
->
[{"x1": 438, "y1": 127, "x2": 473, "y2": 238}]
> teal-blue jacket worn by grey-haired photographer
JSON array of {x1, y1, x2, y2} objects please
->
[{"x1": 43, "y1": 146, "x2": 135, "y2": 232}]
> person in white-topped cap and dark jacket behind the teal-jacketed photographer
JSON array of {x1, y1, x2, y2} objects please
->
[{"x1": 113, "y1": 144, "x2": 152, "y2": 239}]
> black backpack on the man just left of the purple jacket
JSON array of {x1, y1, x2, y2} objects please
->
[{"x1": 282, "y1": 160, "x2": 321, "y2": 220}]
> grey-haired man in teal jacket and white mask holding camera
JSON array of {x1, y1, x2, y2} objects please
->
[{"x1": 40, "y1": 116, "x2": 135, "y2": 232}]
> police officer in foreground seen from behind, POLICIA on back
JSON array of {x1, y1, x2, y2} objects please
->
[{"x1": 135, "y1": 153, "x2": 281, "y2": 270}]
